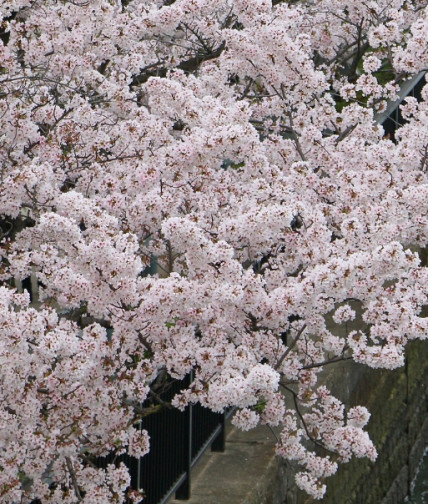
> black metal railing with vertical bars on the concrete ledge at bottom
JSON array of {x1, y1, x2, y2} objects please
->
[{"x1": 96, "y1": 377, "x2": 228, "y2": 504}]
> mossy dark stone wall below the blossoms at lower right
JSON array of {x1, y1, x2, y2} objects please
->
[{"x1": 280, "y1": 341, "x2": 428, "y2": 504}]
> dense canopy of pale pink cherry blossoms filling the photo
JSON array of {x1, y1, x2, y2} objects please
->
[{"x1": 0, "y1": 0, "x2": 428, "y2": 504}]
